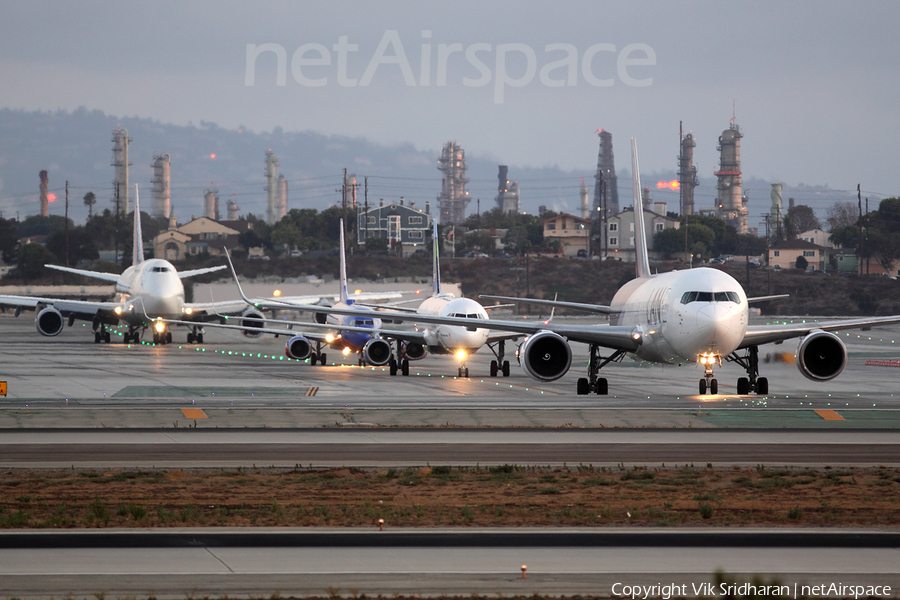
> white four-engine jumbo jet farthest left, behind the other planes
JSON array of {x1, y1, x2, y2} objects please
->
[{"x1": 0, "y1": 185, "x2": 262, "y2": 344}]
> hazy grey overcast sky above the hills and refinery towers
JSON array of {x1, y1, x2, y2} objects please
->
[{"x1": 0, "y1": 0, "x2": 900, "y2": 195}]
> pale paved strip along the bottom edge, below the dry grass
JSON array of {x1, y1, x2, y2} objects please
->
[{"x1": 0, "y1": 529, "x2": 900, "y2": 598}]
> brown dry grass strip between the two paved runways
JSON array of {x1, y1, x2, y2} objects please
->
[{"x1": 0, "y1": 465, "x2": 900, "y2": 528}]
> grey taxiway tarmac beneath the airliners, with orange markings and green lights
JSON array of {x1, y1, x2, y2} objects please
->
[{"x1": 0, "y1": 313, "x2": 900, "y2": 428}]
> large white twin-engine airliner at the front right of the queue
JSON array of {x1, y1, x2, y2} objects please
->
[{"x1": 251, "y1": 139, "x2": 900, "y2": 395}]
